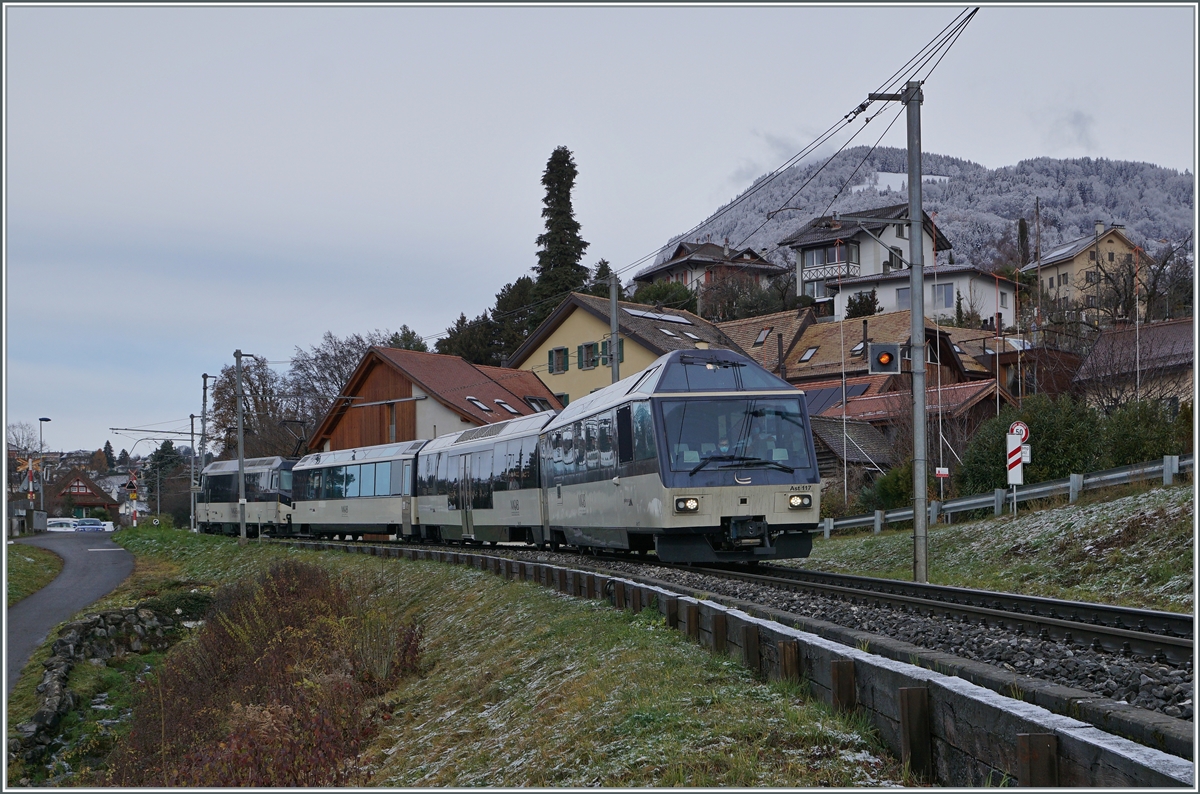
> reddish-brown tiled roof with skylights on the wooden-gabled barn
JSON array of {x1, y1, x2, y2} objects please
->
[{"x1": 367, "y1": 348, "x2": 562, "y2": 425}]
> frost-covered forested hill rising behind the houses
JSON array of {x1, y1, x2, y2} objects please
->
[{"x1": 659, "y1": 146, "x2": 1194, "y2": 272}]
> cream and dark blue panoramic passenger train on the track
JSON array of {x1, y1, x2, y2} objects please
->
[{"x1": 200, "y1": 348, "x2": 821, "y2": 563}]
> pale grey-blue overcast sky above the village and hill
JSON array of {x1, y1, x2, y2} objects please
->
[{"x1": 5, "y1": 5, "x2": 1196, "y2": 453}]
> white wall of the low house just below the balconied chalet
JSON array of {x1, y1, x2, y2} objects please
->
[{"x1": 834, "y1": 270, "x2": 1016, "y2": 327}]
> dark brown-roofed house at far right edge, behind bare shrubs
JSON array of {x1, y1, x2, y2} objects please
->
[{"x1": 1073, "y1": 317, "x2": 1195, "y2": 414}]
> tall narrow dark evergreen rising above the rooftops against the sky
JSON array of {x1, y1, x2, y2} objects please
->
[{"x1": 529, "y1": 146, "x2": 589, "y2": 331}]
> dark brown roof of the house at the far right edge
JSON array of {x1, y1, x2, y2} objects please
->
[{"x1": 1075, "y1": 317, "x2": 1195, "y2": 383}]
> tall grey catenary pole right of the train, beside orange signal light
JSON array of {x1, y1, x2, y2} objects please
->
[{"x1": 869, "y1": 80, "x2": 936, "y2": 583}]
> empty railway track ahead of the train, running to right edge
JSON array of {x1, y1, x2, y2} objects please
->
[{"x1": 655, "y1": 561, "x2": 1193, "y2": 664}]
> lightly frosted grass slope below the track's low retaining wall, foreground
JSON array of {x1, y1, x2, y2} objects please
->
[{"x1": 10, "y1": 529, "x2": 904, "y2": 787}]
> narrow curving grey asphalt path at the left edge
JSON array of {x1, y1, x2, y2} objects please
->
[{"x1": 5, "y1": 533, "x2": 133, "y2": 692}]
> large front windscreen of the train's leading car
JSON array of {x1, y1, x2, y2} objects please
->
[{"x1": 662, "y1": 397, "x2": 810, "y2": 471}]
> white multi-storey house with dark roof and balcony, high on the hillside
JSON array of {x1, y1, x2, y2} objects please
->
[{"x1": 779, "y1": 204, "x2": 952, "y2": 307}]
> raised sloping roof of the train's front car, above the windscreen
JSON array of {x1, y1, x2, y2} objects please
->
[{"x1": 546, "y1": 348, "x2": 800, "y2": 431}]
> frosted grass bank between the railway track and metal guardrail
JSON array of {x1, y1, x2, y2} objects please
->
[{"x1": 803, "y1": 483, "x2": 1195, "y2": 613}]
